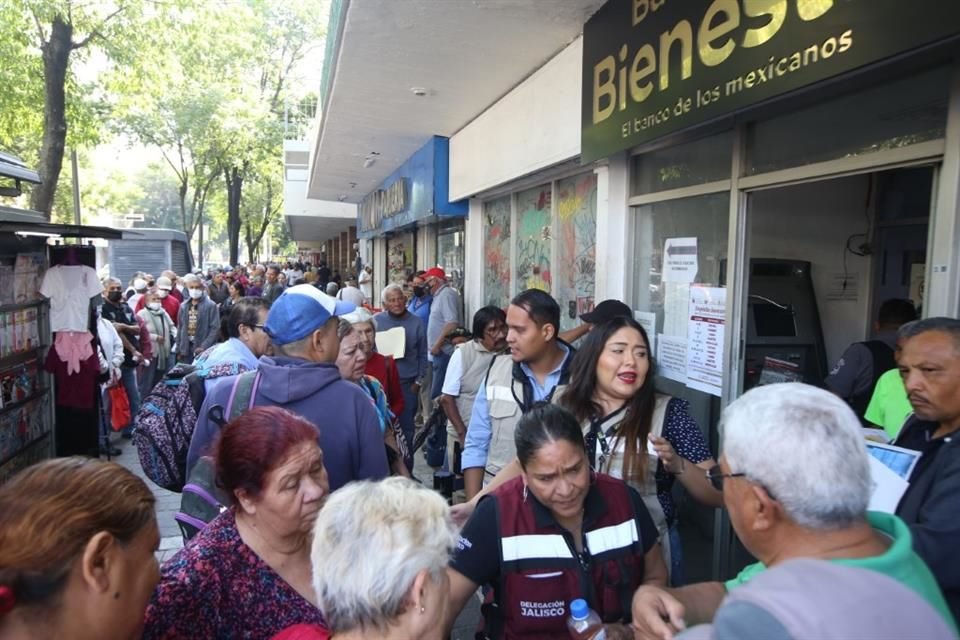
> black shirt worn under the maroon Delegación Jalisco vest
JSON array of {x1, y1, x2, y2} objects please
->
[{"x1": 450, "y1": 486, "x2": 658, "y2": 585}]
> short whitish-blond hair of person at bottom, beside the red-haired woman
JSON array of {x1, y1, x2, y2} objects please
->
[{"x1": 310, "y1": 478, "x2": 457, "y2": 633}]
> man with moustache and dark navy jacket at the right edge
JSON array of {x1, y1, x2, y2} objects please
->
[{"x1": 895, "y1": 318, "x2": 960, "y2": 620}]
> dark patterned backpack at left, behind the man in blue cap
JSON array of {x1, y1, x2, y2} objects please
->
[{"x1": 133, "y1": 363, "x2": 248, "y2": 492}]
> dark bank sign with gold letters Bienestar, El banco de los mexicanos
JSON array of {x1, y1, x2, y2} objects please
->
[{"x1": 581, "y1": 0, "x2": 960, "y2": 162}]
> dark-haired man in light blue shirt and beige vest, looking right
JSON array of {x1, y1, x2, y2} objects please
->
[{"x1": 461, "y1": 289, "x2": 574, "y2": 500}]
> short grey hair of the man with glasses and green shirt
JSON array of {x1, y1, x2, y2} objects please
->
[{"x1": 720, "y1": 382, "x2": 873, "y2": 530}]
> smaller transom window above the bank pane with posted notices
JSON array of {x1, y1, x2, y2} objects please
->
[{"x1": 630, "y1": 131, "x2": 733, "y2": 196}]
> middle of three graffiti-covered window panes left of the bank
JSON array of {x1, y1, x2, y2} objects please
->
[{"x1": 516, "y1": 184, "x2": 553, "y2": 292}]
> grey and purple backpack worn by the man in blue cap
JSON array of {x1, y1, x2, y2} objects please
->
[{"x1": 173, "y1": 371, "x2": 260, "y2": 543}]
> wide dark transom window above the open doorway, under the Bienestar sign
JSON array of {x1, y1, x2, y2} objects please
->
[{"x1": 746, "y1": 68, "x2": 950, "y2": 175}]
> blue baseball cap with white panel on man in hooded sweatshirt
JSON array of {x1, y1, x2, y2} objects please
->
[{"x1": 263, "y1": 284, "x2": 357, "y2": 345}]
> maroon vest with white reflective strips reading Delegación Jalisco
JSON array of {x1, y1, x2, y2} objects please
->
[{"x1": 484, "y1": 474, "x2": 644, "y2": 638}]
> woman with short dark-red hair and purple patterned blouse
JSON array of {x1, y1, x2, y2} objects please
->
[{"x1": 143, "y1": 407, "x2": 329, "y2": 639}]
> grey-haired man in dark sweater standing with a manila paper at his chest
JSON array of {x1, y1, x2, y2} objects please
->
[{"x1": 373, "y1": 284, "x2": 427, "y2": 470}]
